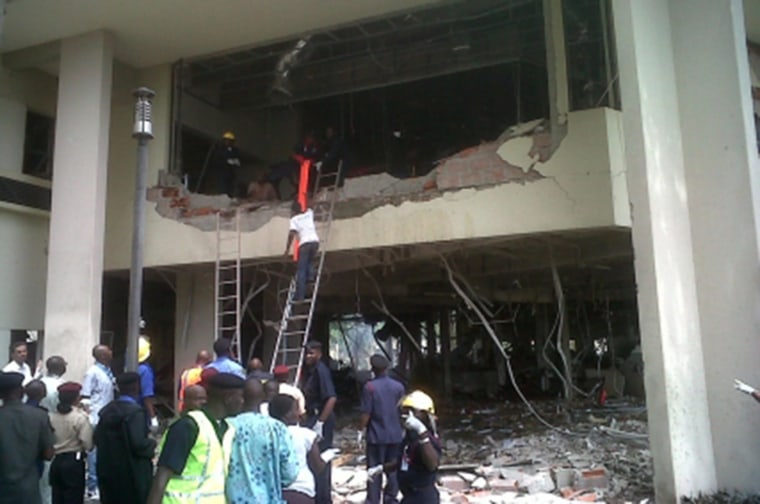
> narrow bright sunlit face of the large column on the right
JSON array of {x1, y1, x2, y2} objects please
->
[{"x1": 613, "y1": 0, "x2": 717, "y2": 502}]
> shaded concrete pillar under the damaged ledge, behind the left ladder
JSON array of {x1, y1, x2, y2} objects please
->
[{"x1": 174, "y1": 265, "x2": 214, "y2": 398}]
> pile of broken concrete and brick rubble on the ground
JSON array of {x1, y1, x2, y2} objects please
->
[{"x1": 333, "y1": 402, "x2": 654, "y2": 504}]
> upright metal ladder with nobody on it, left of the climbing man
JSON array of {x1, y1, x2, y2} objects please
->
[{"x1": 214, "y1": 208, "x2": 241, "y2": 352}]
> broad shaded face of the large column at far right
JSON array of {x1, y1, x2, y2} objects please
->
[{"x1": 670, "y1": 0, "x2": 760, "y2": 493}]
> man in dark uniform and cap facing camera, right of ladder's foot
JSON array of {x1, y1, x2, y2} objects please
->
[{"x1": 301, "y1": 341, "x2": 337, "y2": 504}]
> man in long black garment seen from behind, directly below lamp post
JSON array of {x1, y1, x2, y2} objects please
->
[{"x1": 95, "y1": 372, "x2": 156, "y2": 504}]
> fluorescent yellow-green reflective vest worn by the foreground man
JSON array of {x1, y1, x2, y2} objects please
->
[{"x1": 161, "y1": 411, "x2": 234, "y2": 504}]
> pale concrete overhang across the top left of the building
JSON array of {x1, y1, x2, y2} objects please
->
[{"x1": 0, "y1": 0, "x2": 441, "y2": 68}]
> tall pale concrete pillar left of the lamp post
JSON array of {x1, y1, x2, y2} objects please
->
[{"x1": 45, "y1": 32, "x2": 113, "y2": 380}]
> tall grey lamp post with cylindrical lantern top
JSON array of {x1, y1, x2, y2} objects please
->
[{"x1": 126, "y1": 87, "x2": 156, "y2": 371}]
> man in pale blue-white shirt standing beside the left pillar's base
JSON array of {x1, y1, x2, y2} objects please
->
[{"x1": 82, "y1": 345, "x2": 114, "y2": 499}]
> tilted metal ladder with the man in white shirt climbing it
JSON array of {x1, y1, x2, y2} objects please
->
[{"x1": 269, "y1": 161, "x2": 343, "y2": 384}]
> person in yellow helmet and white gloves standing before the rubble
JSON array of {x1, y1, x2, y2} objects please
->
[{"x1": 367, "y1": 390, "x2": 441, "y2": 504}]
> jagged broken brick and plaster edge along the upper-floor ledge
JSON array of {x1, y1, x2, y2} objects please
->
[{"x1": 148, "y1": 120, "x2": 553, "y2": 232}]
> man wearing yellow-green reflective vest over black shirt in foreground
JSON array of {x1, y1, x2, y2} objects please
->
[{"x1": 147, "y1": 373, "x2": 245, "y2": 504}]
